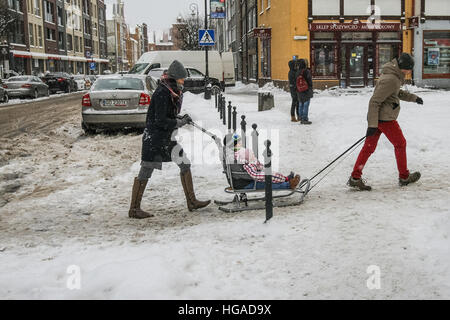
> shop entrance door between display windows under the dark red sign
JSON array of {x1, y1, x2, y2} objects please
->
[{"x1": 341, "y1": 43, "x2": 374, "y2": 87}]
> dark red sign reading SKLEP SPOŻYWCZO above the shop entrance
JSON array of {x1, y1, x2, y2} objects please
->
[{"x1": 309, "y1": 22, "x2": 401, "y2": 32}]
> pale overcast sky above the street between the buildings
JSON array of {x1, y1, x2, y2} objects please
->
[{"x1": 105, "y1": 0, "x2": 209, "y2": 30}]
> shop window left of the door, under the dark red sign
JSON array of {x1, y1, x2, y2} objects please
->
[{"x1": 312, "y1": 44, "x2": 336, "y2": 77}]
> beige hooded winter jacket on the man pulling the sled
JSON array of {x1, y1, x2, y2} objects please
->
[{"x1": 367, "y1": 59, "x2": 417, "y2": 128}]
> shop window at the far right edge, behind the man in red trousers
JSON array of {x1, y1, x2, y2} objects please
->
[{"x1": 423, "y1": 31, "x2": 450, "y2": 77}]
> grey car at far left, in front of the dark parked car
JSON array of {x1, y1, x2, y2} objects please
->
[{"x1": 3, "y1": 76, "x2": 50, "y2": 99}]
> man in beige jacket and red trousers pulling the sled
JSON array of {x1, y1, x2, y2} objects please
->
[{"x1": 348, "y1": 53, "x2": 423, "y2": 191}]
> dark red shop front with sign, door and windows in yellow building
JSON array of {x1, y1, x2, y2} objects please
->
[{"x1": 309, "y1": 21, "x2": 402, "y2": 88}]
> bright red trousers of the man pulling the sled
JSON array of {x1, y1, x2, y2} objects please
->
[{"x1": 352, "y1": 121, "x2": 409, "y2": 179}]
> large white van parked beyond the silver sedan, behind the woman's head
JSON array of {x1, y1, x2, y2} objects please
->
[{"x1": 129, "y1": 51, "x2": 225, "y2": 88}]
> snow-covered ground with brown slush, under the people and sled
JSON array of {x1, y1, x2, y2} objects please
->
[{"x1": 0, "y1": 83, "x2": 450, "y2": 299}]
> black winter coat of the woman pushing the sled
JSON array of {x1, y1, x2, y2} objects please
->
[{"x1": 142, "y1": 83, "x2": 183, "y2": 162}]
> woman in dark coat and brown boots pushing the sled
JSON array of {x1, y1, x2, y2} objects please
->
[{"x1": 128, "y1": 60, "x2": 210, "y2": 219}]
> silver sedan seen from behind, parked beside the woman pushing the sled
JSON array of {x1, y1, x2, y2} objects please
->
[{"x1": 81, "y1": 75, "x2": 157, "y2": 134}]
